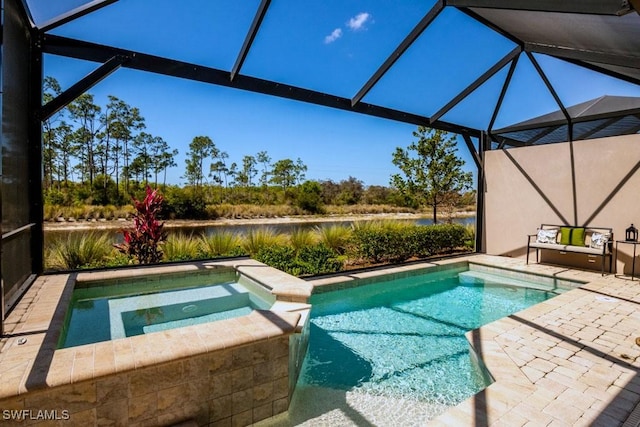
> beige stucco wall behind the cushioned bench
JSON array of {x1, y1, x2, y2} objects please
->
[{"x1": 485, "y1": 135, "x2": 640, "y2": 274}]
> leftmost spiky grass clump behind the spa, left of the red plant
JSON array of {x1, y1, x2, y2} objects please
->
[{"x1": 45, "y1": 232, "x2": 114, "y2": 270}]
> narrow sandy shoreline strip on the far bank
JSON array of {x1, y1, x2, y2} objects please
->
[{"x1": 44, "y1": 212, "x2": 475, "y2": 231}]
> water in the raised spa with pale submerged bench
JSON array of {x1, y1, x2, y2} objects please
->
[{"x1": 58, "y1": 267, "x2": 275, "y2": 348}]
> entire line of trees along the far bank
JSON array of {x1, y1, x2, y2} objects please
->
[{"x1": 43, "y1": 77, "x2": 474, "y2": 219}]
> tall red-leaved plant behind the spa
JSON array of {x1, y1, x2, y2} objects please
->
[{"x1": 114, "y1": 185, "x2": 167, "y2": 264}]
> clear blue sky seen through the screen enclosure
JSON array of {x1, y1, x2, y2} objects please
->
[{"x1": 28, "y1": 0, "x2": 640, "y2": 185}]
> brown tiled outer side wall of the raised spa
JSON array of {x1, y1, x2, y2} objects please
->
[{"x1": 0, "y1": 335, "x2": 290, "y2": 426}]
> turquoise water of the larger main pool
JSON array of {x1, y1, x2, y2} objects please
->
[{"x1": 289, "y1": 267, "x2": 565, "y2": 425}]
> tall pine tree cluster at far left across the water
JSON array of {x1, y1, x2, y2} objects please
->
[{"x1": 42, "y1": 77, "x2": 178, "y2": 204}]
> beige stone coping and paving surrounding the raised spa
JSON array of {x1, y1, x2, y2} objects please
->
[{"x1": 0, "y1": 259, "x2": 312, "y2": 399}]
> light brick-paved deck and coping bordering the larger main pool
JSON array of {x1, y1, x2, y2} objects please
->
[{"x1": 304, "y1": 254, "x2": 640, "y2": 427}]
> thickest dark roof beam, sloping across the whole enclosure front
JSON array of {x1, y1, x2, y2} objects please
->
[{"x1": 42, "y1": 34, "x2": 480, "y2": 136}]
